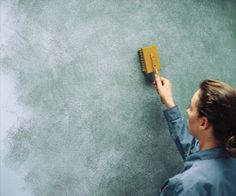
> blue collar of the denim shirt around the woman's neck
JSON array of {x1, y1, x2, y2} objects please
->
[{"x1": 186, "y1": 147, "x2": 229, "y2": 161}]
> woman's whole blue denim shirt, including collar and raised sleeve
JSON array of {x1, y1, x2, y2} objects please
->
[{"x1": 160, "y1": 106, "x2": 236, "y2": 196}]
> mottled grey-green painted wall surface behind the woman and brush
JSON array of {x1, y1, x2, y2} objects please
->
[{"x1": 1, "y1": 0, "x2": 236, "y2": 196}]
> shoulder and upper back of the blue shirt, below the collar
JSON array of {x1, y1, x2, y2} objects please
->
[{"x1": 162, "y1": 159, "x2": 236, "y2": 196}]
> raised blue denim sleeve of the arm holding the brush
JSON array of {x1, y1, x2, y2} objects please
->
[{"x1": 164, "y1": 106, "x2": 198, "y2": 160}]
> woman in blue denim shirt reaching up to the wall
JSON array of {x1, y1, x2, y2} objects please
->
[{"x1": 153, "y1": 77, "x2": 236, "y2": 196}]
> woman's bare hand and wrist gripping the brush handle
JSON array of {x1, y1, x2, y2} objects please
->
[{"x1": 153, "y1": 76, "x2": 175, "y2": 108}]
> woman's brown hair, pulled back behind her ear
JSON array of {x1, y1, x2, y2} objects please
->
[{"x1": 198, "y1": 80, "x2": 236, "y2": 156}]
